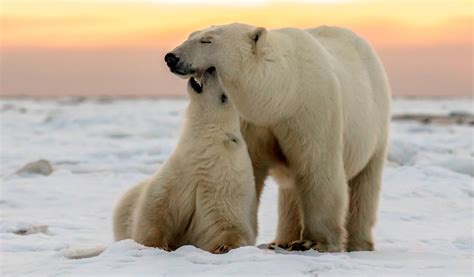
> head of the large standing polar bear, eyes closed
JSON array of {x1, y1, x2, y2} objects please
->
[{"x1": 165, "y1": 23, "x2": 266, "y2": 83}]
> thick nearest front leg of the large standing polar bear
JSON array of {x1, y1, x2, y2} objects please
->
[{"x1": 273, "y1": 108, "x2": 348, "y2": 252}]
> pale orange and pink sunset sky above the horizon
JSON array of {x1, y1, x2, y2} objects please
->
[{"x1": 0, "y1": 0, "x2": 473, "y2": 96}]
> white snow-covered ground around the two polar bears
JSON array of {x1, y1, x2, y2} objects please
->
[{"x1": 0, "y1": 99, "x2": 474, "y2": 276}]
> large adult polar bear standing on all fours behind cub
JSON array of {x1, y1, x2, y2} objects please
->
[{"x1": 165, "y1": 23, "x2": 390, "y2": 252}]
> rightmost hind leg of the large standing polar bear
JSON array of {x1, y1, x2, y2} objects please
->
[{"x1": 346, "y1": 149, "x2": 385, "y2": 251}]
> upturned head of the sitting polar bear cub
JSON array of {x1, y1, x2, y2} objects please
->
[{"x1": 187, "y1": 67, "x2": 239, "y2": 126}]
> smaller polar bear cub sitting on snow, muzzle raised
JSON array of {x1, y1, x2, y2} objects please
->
[{"x1": 113, "y1": 70, "x2": 257, "y2": 253}]
